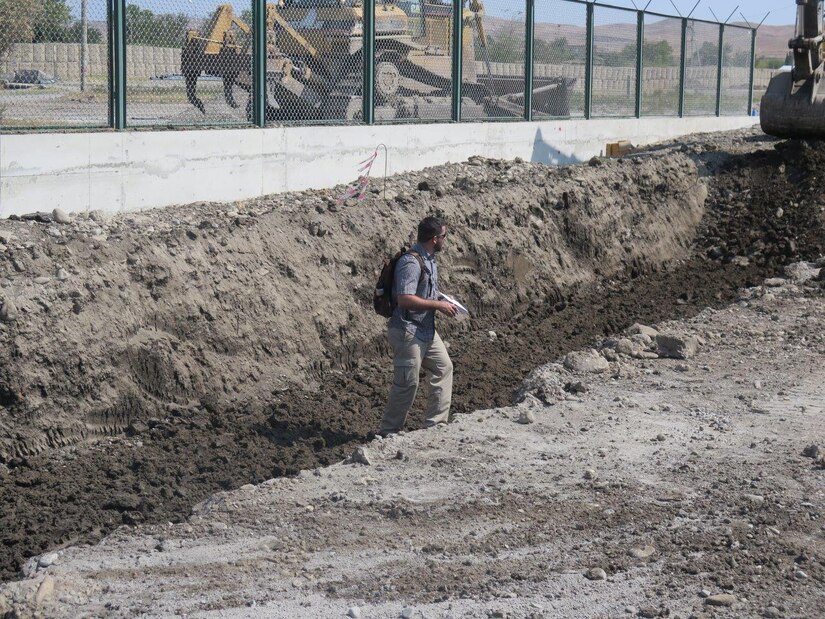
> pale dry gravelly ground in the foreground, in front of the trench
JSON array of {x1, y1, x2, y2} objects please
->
[{"x1": 0, "y1": 272, "x2": 825, "y2": 619}]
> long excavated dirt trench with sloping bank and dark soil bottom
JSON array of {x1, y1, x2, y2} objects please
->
[{"x1": 0, "y1": 127, "x2": 825, "y2": 578}]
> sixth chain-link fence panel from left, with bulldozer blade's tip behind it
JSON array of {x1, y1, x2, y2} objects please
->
[{"x1": 533, "y1": 0, "x2": 587, "y2": 120}]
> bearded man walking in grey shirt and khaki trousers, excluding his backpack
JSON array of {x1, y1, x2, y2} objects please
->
[{"x1": 378, "y1": 217, "x2": 458, "y2": 436}]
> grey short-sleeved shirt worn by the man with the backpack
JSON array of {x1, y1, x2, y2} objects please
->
[{"x1": 389, "y1": 243, "x2": 438, "y2": 342}]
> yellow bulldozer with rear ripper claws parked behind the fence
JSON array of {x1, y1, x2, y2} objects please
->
[{"x1": 181, "y1": 0, "x2": 571, "y2": 122}]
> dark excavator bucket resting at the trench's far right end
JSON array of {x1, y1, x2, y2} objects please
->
[{"x1": 759, "y1": 71, "x2": 825, "y2": 138}]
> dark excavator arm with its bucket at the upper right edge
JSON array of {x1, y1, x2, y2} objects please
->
[{"x1": 760, "y1": 0, "x2": 825, "y2": 138}]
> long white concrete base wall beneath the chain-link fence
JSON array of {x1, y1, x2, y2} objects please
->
[{"x1": 0, "y1": 116, "x2": 757, "y2": 217}]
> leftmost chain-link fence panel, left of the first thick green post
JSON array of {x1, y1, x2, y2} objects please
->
[{"x1": 0, "y1": 0, "x2": 109, "y2": 130}]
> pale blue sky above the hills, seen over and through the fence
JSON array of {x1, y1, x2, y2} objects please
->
[{"x1": 67, "y1": 0, "x2": 796, "y2": 26}]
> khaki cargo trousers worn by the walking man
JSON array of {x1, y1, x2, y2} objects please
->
[{"x1": 379, "y1": 328, "x2": 453, "y2": 434}]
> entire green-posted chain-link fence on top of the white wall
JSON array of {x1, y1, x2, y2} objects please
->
[{"x1": 0, "y1": 0, "x2": 753, "y2": 130}]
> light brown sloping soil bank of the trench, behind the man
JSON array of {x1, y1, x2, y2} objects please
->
[{"x1": 0, "y1": 154, "x2": 706, "y2": 461}]
